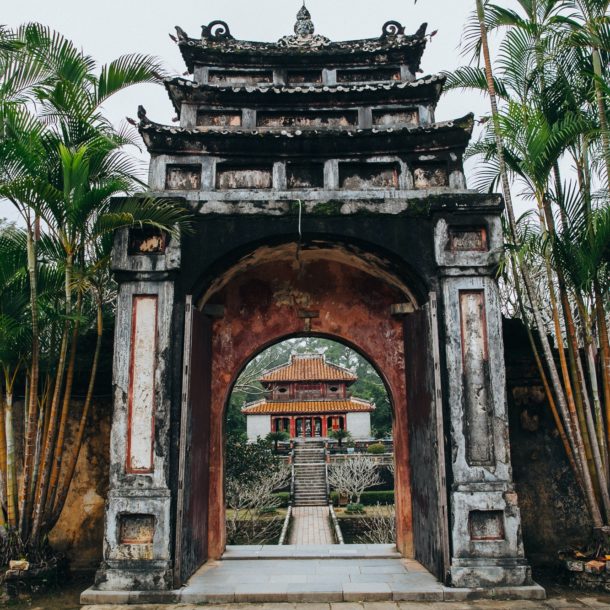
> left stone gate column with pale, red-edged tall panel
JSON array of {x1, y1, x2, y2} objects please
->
[{"x1": 96, "y1": 231, "x2": 180, "y2": 591}]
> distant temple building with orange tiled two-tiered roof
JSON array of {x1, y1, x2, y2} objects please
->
[{"x1": 242, "y1": 354, "x2": 375, "y2": 440}]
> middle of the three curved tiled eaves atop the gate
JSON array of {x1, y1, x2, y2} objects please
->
[{"x1": 164, "y1": 73, "x2": 447, "y2": 93}]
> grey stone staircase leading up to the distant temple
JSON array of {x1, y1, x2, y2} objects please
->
[{"x1": 292, "y1": 439, "x2": 328, "y2": 506}]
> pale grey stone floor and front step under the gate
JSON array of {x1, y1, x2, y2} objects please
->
[{"x1": 81, "y1": 557, "x2": 548, "y2": 610}]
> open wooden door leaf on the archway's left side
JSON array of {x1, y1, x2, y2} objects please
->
[{"x1": 174, "y1": 296, "x2": 212, "y2": 587}]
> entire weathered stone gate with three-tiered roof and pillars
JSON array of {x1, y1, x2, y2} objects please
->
[{"x1": 96, "y1": 8, "x2": 531, "y2": 590}]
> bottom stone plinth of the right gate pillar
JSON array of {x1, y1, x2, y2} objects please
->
[{"x1": 450, "y1": 558, "x2": 533, "y2": 589}]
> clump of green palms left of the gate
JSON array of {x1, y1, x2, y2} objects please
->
[{"x1": 0, "y1": 24, "x2": 188, "y2": 549}]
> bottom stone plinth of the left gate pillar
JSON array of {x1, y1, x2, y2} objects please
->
[{"x1": 94, "y1": 561, "x2": 173, "y2": 591}]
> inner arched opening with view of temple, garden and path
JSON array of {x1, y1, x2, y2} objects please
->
[{"x1": 224, "y1": 335, "x2": 395, "y2": 545}]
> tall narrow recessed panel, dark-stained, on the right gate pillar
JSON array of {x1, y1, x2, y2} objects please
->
[{"x1": 459, "y1": 290, "x2": 494, "y2": 466}]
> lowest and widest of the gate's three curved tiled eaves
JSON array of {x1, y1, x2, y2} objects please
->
[{"x1": 139, "y1": 112, "x2": 474, "y2": 138}]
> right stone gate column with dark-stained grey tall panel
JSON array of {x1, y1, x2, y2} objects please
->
[{"x1": 435, "y1": 213, "x2": 531, "y2": 587}]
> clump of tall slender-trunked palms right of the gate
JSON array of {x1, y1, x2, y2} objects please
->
[{"x1": 442, "y1": 0, "x2": 610, "y2": 527}]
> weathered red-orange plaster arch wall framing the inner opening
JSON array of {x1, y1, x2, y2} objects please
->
[{"x1": 183, "y1": 244, "x2": 417, "y2": 558}]
